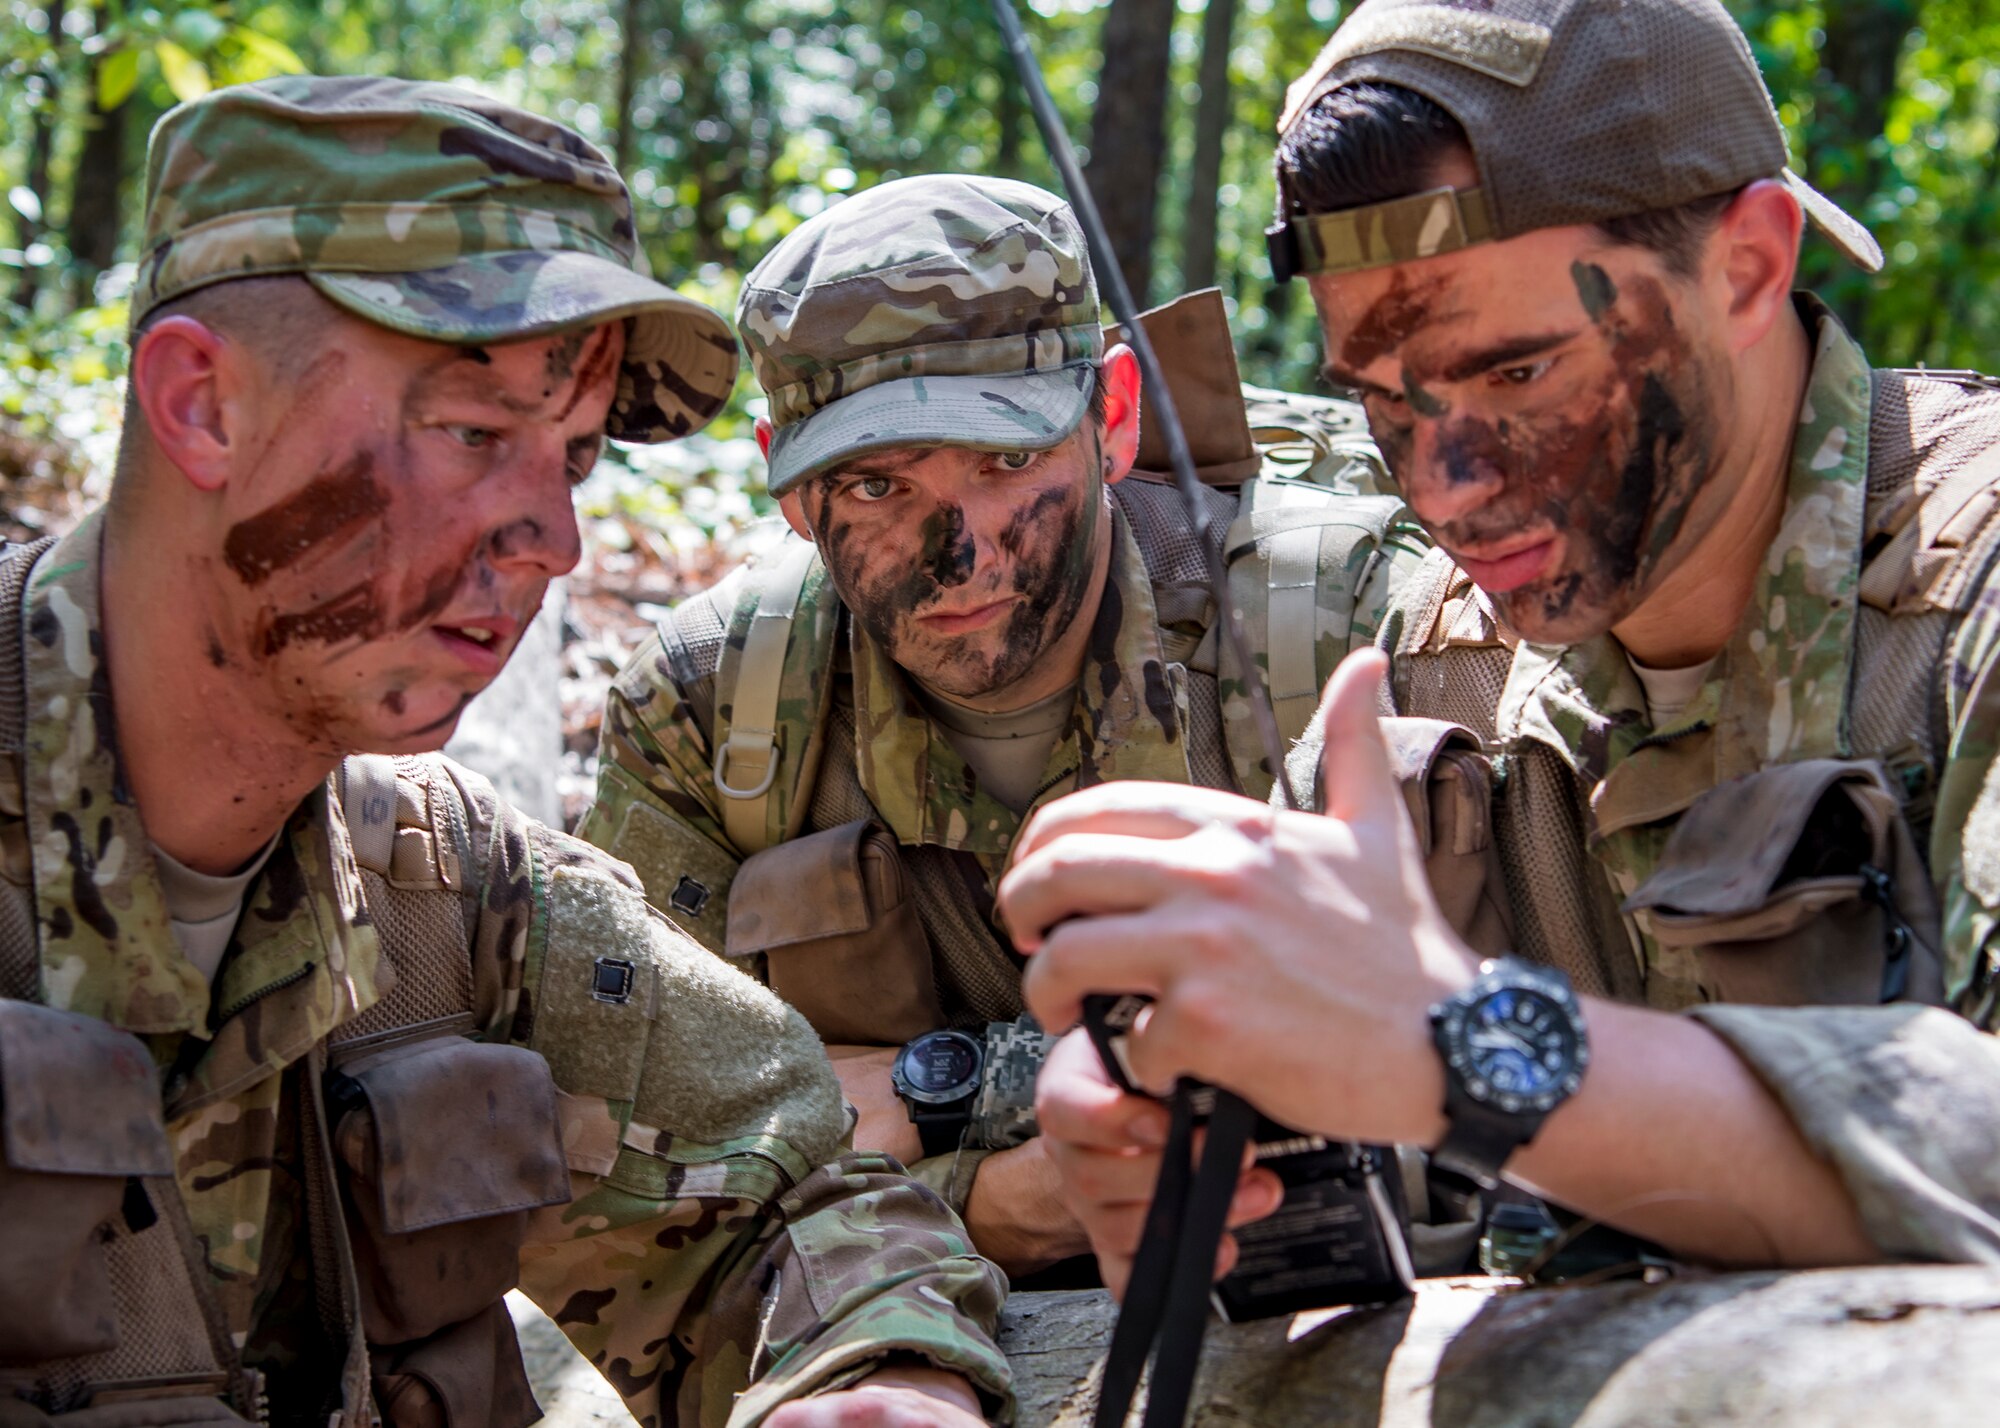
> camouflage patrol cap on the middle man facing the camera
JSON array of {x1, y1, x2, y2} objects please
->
[{"x1": 736, "y1": 174, "x2": 1104, "y2": 494}]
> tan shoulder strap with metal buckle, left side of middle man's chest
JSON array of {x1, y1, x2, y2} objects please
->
[{"x1": 714, "y1": 540, "x2": 838, "y2": 844}]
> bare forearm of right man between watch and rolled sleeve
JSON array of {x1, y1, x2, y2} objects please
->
[{"x1": 1508, "y1": 1000, "x2": 1884, "y2": 1266}]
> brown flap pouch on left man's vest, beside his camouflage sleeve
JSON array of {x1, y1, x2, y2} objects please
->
[{"x1": 326, "y1": 1018, "x2": 570, "y2": 1344}]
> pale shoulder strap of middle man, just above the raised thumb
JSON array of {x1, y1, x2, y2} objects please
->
[{"x1": 1218, "y1": 478, "x2": 1408, "y2": 798}]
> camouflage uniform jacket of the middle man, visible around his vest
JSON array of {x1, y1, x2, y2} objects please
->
[{"x1": 578, "y1": 478, "x2": 1422, "y2": 1204}]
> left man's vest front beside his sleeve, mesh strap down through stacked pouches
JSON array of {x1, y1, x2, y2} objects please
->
[{"x1": 322, "y1": 756, "x2": 570, "y2": 1428}]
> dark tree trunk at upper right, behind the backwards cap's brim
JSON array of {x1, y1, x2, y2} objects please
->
[{"x1": 1806, "y1": 0, "x2": 1922, "y2": 336}]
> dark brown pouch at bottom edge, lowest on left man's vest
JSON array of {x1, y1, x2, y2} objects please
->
[{"x1": 374, "y1": 1300, "x2": 542, "y2": 1428}]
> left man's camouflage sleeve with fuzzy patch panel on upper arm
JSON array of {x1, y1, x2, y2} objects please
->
[{"x1": 486, "y1": 812, "x2": 1012, "y2": 1428}]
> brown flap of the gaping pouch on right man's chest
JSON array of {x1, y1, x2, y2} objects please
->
[{"x1": 1624, "y1": 758, "x2": 1896, "y2": 916}]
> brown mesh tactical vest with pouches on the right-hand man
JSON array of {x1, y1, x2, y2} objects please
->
[{"x1": 1368, "y1": 370, "x2": 2000, "y2": 1016}]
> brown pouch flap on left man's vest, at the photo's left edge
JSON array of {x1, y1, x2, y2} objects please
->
[{"x1": 0, "y1": 1002, "x2": 174, "y2": 1176}]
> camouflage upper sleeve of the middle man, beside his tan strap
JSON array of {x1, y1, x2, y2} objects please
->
[{"x1": 576, "y1": 634, "x2": 738, "y2": 952}]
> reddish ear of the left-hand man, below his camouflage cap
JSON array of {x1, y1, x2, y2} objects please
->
[{"x1": 132, "y1": 316, "x2": 246, "y2": 490}]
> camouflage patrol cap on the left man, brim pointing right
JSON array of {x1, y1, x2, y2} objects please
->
[{"x1": 132, "y1": 74, "x2": 736, "y2": 442}]
